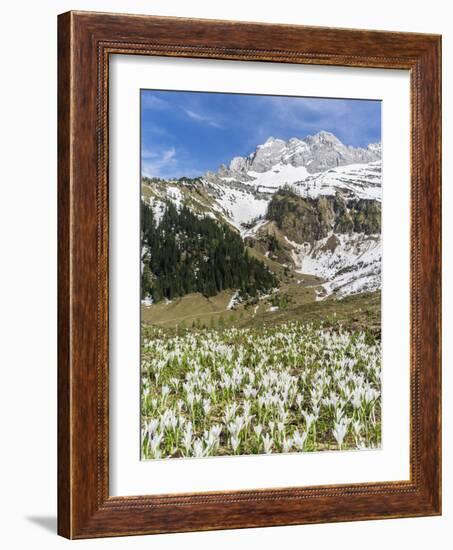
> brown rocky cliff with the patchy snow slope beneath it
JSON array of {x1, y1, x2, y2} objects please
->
[{"x1": 260, "y1": 188, "x2": 381, "y2": 299}]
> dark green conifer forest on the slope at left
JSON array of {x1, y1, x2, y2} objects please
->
[{"x1": 141, "y1": 202, "x2": 276, "y2": 302}]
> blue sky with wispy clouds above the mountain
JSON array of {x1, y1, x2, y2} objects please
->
[{"x1": 141, "y1": 90, "x2": 381, "y2": 178}]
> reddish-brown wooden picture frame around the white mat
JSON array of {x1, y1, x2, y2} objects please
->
[{"x1": 58, "y1": 12, "x2": 441, "y2": 539}]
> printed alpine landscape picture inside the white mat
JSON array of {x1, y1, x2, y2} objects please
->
[{"x1": 140, "y1": 90, "x2": 382, "y2": 460}]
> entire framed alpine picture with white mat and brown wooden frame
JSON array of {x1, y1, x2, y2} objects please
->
[{"x1": 58, "y1": 12, "x2": 441, "y2": 538}]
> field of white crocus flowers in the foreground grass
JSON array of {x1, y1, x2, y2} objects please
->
[{"x1": 141, "y1": 322, "x2": 381, "y2": 459}]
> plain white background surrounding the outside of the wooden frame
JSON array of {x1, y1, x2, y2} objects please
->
[{"x1": 0, "y1": 0, "x2": 453, "y2": 550}]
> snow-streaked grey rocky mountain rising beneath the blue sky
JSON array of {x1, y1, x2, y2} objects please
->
[{"x1": 142, "y1": 131, "x2": 381, "y2": 299}]
